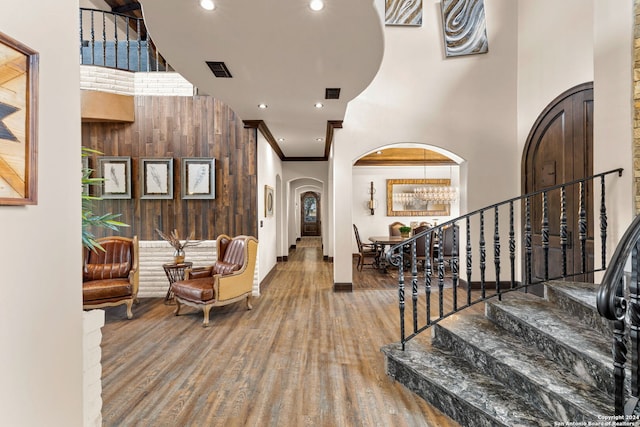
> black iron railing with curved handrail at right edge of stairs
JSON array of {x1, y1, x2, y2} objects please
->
[{"x1": 596, "y1": 211, "x2": 640, "y2": 420}]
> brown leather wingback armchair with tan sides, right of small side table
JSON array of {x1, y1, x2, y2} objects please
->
[{"x1": 171, "y1": 234, "x2": 258, "y2": 328}]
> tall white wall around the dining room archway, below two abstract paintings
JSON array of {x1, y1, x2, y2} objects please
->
[{"x1": 332, "y1": 0, "x2": 520, "y2": 283}]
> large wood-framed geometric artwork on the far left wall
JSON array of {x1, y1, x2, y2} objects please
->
[{"x1": 0, "y1": 33, "x2": 38, "y2": 205}]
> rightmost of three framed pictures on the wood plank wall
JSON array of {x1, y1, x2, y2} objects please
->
[{"x1": 181, "y1": 157, "x2": 216, "y2": 199}]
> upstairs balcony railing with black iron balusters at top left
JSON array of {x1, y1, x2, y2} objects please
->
[{"x1": 79, "y1": 8, "x2": 173, "y2": 72}]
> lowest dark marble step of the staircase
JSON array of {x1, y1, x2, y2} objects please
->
[{"x1": 382, "y1": 341, "x2": 553, "y2": 427}]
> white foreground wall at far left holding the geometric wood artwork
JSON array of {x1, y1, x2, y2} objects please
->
[{"x1": 0, "y1": 0, "x2": 83, "y2": 427}]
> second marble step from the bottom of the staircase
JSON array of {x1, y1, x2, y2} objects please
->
[{"x1": 434, "y1": 313, "x2": 613, "y2": 421}]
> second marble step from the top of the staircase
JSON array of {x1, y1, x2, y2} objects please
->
[{"x1": 485, "y1": 292, "x2": 614, "y2": 395}]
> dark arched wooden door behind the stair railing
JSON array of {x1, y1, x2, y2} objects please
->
[{"x1": 523, "y1": 83, "x2": 594, "y2": 282}]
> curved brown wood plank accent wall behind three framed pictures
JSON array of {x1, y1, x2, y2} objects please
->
[{"x1": 82, "y1": 96, "x2": 257, "y2": 240}]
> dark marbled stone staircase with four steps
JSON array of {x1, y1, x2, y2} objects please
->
[{"x1": 382, "y1": 282, "x2": 616, "y2": 427}]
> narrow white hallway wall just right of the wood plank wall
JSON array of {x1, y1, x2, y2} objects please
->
[{"x1": 257, "y1": 131, "x2": 285, "y2": 282}]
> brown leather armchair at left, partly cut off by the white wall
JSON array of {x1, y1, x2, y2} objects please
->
[{"x1": 82, "y1": 236, "x2": 139, "y2": 319}]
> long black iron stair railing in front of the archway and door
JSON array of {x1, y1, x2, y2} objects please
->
[{"x1": 386, "y1": 168, "x2": 624, "y2": 350}]
